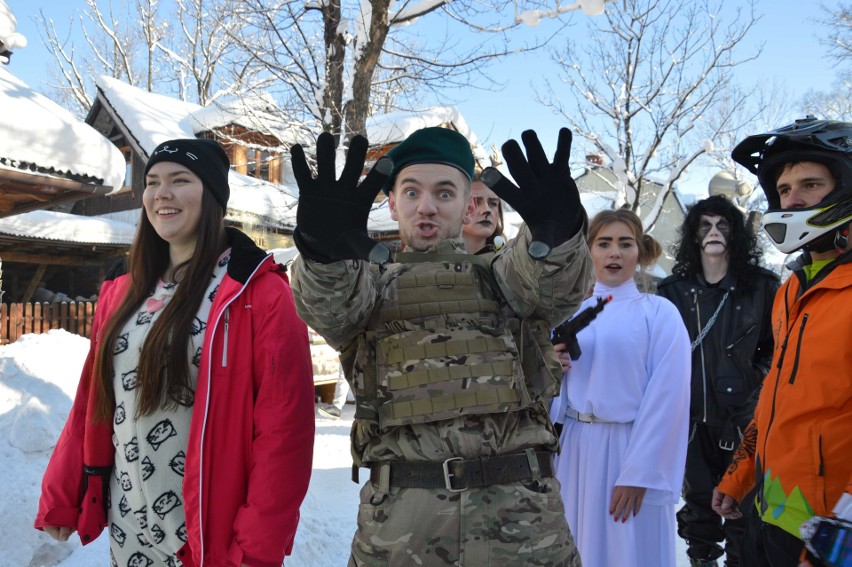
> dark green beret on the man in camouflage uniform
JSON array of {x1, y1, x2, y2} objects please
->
[{"x1": 382, "y1": 126, "x2": 474, "y2": 195}]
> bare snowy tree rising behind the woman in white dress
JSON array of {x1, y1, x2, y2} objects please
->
[{"x1": 540, "y1": 0, "x2": 759, "y2": 229}]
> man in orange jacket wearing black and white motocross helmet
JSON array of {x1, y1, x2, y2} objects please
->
[{"x1": 712, "y1": 116, "x2": 852, "y2": 567}]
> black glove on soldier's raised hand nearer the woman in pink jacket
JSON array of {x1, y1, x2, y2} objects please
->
[{"x1": 290, "y1": 132, "x2": 393, "y2": 264}]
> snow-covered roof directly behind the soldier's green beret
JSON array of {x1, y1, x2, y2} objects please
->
[{"x1": 366, "y1": 106, "x2": 491, "y2": 167}]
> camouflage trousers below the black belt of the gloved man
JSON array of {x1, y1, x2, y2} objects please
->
[{"x1": 349, "y1": 478, "x2": 580, "y2": 567}]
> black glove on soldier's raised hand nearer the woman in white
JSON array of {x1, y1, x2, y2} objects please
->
[{"x1": 482, "y1": 128, "x2": 585, "y2": 260}]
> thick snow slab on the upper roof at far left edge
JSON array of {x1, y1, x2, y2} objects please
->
[{"x1": 0, "y1": 67, "x2": 126, "y2": 194}]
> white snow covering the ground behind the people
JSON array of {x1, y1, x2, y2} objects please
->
[{"x1": 0, "y1": 330, "x2": 700, "y2": 567}]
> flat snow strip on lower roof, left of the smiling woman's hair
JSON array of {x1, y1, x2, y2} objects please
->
[{"x1": 0, "y1": 211, "x2": 136, "y2": 245}]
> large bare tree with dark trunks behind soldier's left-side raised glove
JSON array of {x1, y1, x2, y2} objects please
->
[{"x1": 223, "y1": 0, "x2": 584, "y2": 144}]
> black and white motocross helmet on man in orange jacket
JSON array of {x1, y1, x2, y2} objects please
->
[{"x1": 731, "y1": 115, "x2": 852, "y2": 253}]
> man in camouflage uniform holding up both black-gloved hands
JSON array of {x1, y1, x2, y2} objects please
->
[{"x1": 292, "y1": 128, "x2": 591, "y2": 567}]
